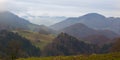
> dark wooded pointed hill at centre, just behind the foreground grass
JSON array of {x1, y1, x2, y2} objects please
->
[{"x1": 43, "y1": 33, "x2": 95, "y2": 56}]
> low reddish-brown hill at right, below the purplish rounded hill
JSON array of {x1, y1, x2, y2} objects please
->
[{"x1": 83, "y1": 35, "x2": 113, "y2": 46}]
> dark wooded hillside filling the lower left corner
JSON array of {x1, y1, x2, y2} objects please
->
[{"x1": 0, "y1": 30, "x2": 40, "y2": 58}]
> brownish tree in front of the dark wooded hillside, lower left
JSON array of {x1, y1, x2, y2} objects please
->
[{"x1": 7, "y1": 40, "x2": 23, "y2": 60}]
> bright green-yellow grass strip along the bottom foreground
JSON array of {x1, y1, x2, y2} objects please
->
[{"x1": 17, "y1": 53, "x2": 120, "y2": 60}]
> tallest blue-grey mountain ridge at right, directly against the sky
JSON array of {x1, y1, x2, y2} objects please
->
[{"x1": 50, "y1": 13, "x2": 120, "y2": 34}]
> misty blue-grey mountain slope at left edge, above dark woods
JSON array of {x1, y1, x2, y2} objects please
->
[{"x1": 0, "y1": 11, "x2": 33, "y2": 30}]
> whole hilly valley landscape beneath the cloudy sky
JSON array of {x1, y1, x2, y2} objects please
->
[{"x1": 0, "y1": 11, "x2": 120, "y2": 60}]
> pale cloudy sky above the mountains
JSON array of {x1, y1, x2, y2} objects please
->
[{"x1": 0, "y1": 0, "x2": 120, "y2": 25}]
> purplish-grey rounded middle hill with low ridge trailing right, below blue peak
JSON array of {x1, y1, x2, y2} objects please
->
[{"x1": 60, "y1": 23, "x2": 119, "y2": 39}]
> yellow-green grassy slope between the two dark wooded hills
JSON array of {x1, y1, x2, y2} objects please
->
[{"x1": 14, "y1": 31, "x2": 55, "y2": 49}]
